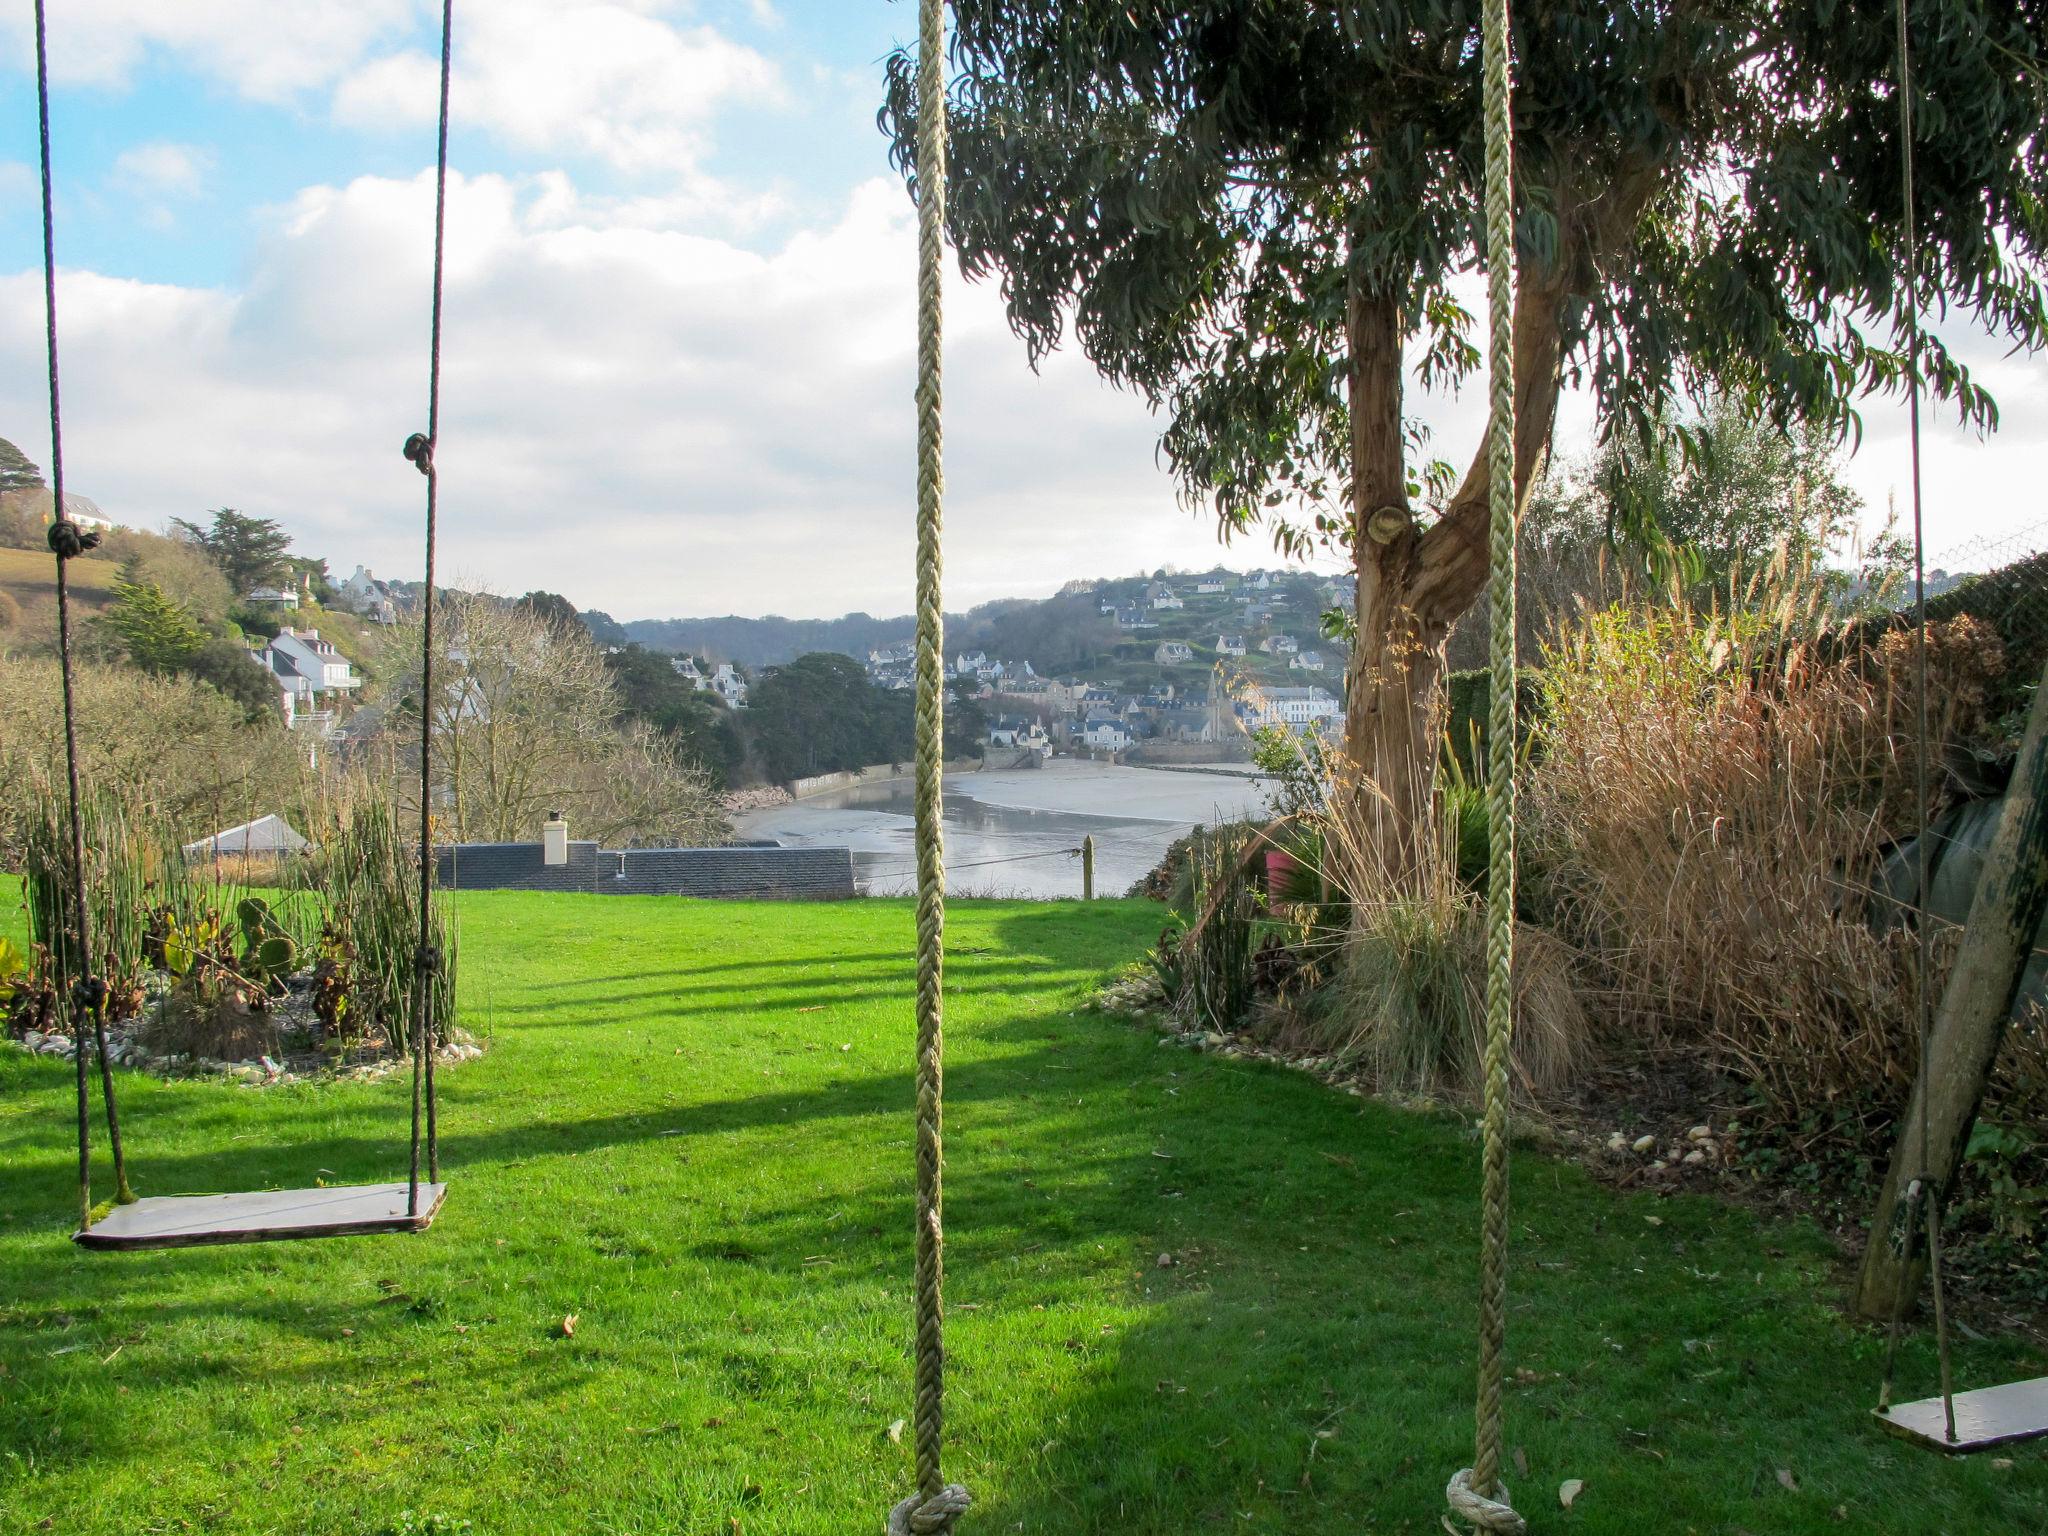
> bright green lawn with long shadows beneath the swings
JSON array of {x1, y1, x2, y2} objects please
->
[{"x1": 0, "y1": 895, "x2": 2048, "y2": 1536}]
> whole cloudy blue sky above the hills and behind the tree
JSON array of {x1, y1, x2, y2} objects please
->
[{"x1": 0, "y1": 0, "x2": 2048, "y2": 616}]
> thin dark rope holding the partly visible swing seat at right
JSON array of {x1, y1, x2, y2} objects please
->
[{"x1": 1870, "y1": 0, "x2": 1956, "y2": 1442}]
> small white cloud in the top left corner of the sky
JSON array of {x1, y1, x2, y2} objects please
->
[{"x1": 0, "y1": 0, "x2": 422, "y2": 102}]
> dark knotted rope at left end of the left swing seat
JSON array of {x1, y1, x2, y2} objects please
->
[{"x1": 35, "y1": 0, "x2": 135, "y2": 1231}]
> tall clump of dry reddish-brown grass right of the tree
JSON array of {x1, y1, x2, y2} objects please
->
[{"x1": 1528, "y1": 571, "x2": 1999, "y2": 1106}]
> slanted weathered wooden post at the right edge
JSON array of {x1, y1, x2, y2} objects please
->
[{"x1": 1855, "y1": 651, "x2": 2048, "y2": 1319}]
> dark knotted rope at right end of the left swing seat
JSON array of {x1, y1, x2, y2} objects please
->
[{"x1": 406, "y1": 0, "x2": 455, "y2": 1217}]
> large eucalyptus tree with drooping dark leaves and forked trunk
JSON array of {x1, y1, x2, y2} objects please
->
[{"x1": 883, "y1": 0, "x2": 2048, "y2": 843}]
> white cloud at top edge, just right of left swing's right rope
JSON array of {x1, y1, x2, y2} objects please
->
[{"x1": 334, "y1": 0, "x2": 784, "y2": 170}]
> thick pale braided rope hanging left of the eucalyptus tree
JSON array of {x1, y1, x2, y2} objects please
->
[{"x1": 889, "y1": 0, "x2": 969, "y2": 1536}]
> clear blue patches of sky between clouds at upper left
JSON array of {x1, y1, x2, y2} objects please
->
[{"x1": 0, "y1": 0, "x2": 913, "y2": 287}]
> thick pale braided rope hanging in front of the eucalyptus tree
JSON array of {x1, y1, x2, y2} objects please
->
[{"x1": 1446, "y1": 0, "x2": 1526, "y2": 1532}]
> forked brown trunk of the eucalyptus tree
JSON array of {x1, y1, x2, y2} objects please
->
[{"x1": 1343, "y1": 268, "x2": 1563, "y2": 879}]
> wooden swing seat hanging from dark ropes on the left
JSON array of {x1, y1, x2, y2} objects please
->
[{"x1": 72, "y1": 1184, "x2": 449, "y2": 1249}]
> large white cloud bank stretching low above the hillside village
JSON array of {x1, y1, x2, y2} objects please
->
[{"x1": 0, "y1": 176, "x2": 1294, "y2": 616}]
